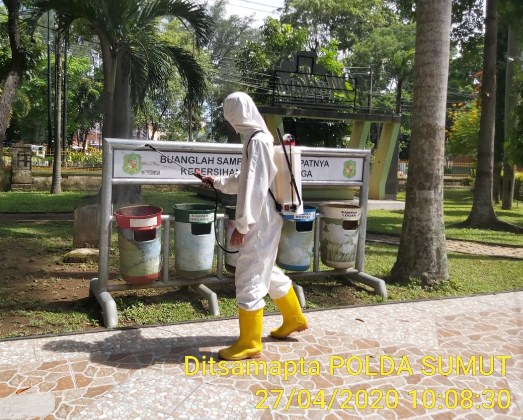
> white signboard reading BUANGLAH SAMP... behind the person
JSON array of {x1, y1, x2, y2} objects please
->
[{"x1": 113, "y1": 150, "x2": 363, "y2": 183}]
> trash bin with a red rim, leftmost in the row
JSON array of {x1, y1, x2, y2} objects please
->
[{"x1": 114, "y1": 205, "x2": 163, "y2": 284}]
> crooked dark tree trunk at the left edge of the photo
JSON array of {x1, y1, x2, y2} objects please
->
[{"x1": 0, "y1": 0, "x2": 27, "y2": 169}]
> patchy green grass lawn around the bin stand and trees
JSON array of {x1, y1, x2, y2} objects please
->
[{"x1": 0, "y1": 188, "x2": 523, "y2": 338}]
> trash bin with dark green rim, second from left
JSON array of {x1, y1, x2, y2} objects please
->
[{"x1": 174, "y1": 204, "x2": 215, "y2": 279}]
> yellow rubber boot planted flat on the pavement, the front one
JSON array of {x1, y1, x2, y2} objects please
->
[{"x1": 218, "y1": 308, "x2": 263, "y2": 360}]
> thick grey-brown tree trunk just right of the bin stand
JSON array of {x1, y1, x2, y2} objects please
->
[{"x1": 391, "y1": 0, "x2": 452, "y2": 283}]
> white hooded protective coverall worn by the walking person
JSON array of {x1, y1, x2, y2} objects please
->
[{"x1": 214, "y1": 92, "x2": 292, "y2": 311}]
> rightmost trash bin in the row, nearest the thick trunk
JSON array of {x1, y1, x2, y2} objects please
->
[{"x1": 320, "y1": 203, "x2": 361, "y2": 268}]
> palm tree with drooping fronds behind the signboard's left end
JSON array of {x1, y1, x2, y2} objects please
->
[{"x1": 35, "y1": 0, "x2": 211, "y2": 137}]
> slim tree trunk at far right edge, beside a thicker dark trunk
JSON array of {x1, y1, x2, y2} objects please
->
[{"x1": 501, "y1": 25, "x2": 519, "y2": 210}]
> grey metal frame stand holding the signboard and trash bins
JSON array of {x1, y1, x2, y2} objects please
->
[{"x1": 89, "y1": 139, "x2": 387, "y2": 328}]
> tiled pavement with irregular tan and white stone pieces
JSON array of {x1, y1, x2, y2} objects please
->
[{"x1": 0, "y1": 291, "x2": 523, "y2": 419}]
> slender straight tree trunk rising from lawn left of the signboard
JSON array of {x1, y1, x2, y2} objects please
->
[{"x1": 51, "y1": 24, "x2": 63, "y2": 194}]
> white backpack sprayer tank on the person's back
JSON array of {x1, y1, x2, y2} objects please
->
[{"x1": 274, "y1": 129, "x2": 303, "y2": 215}]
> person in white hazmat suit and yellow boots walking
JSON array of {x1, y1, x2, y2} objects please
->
[{"x1": 203, "y1": 92, "x2": 308, "y2": 360}]
